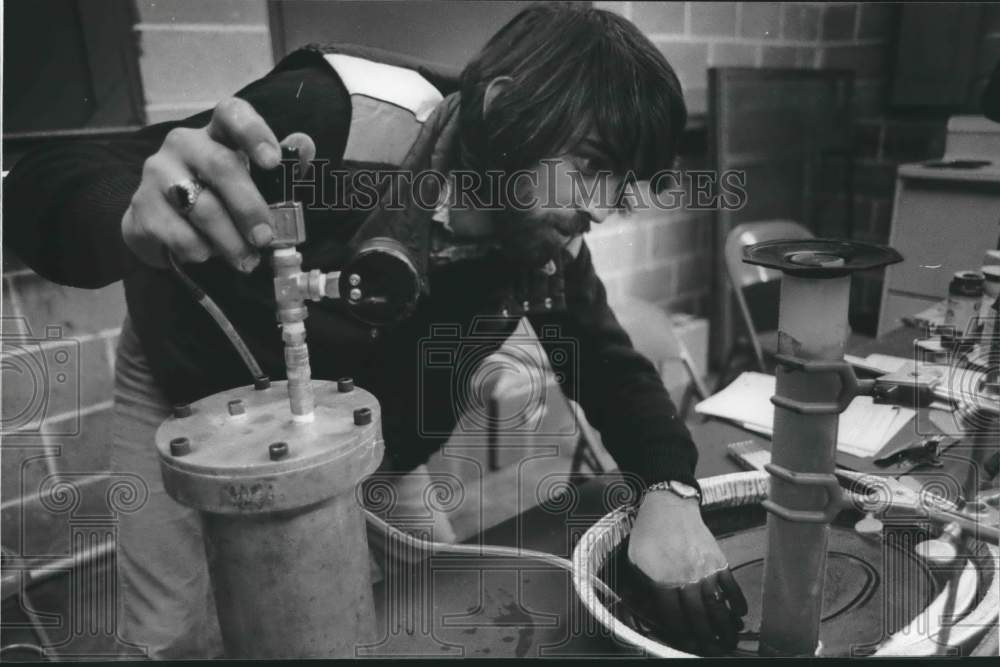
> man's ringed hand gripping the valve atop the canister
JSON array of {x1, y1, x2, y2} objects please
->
[{"x1": 122, "y1": 97, "x2": 316, "y2": 273}]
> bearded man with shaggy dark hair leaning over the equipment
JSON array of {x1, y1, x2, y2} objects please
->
[{"x1": 4, "y1": 5, "x2": 746, "y2": 657}]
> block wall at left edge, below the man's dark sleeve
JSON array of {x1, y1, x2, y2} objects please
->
[{"x1": 0, "y1": 253, "x2": 125, "y2": 567}]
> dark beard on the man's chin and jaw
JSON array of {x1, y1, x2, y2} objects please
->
[{"x1": 497, "y1": 208, "x2": 590, "y2": 267}]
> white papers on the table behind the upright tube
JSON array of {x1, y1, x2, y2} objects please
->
[{"x1": 695, "y1": 371, "x2": 916, "y2": 458}]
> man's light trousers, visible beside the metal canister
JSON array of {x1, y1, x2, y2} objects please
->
[{"x1": 111, "y1": 318, "x2": 454, "y2": 659}]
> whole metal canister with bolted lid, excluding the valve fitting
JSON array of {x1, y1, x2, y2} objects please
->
[{"x1": 156, "y1": 380, "x2": 383, "y2": 659}]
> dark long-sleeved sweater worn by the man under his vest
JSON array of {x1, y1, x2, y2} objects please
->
[{"x1": 3, "y1": 48, "x2": 697, "y2": 484}]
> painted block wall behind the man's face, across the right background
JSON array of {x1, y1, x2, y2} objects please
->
[{"x1": 589, "y1": 2, "x2": 1000, "y2": 333}]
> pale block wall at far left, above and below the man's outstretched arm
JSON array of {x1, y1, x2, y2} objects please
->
[{"x1": 0, "y1": 0, "x2": 272, "y2": 576}]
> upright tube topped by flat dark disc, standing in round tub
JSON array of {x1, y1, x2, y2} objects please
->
[{"x1": 743, "y1": 239, "x2": 903, "y2": 656}]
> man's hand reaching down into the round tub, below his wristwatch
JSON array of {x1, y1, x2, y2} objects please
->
[{"x1": 628, "y1": 491, "x2": 747, "y2": 655}]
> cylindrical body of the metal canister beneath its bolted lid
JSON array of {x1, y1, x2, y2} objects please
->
[{"x1": 203, "y1": 489, "x2": 375, "y2": 659}]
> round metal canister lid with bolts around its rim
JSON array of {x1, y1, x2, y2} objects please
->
[{"x1": 156, "y1": 380, "x2": 383, "y2": 514}]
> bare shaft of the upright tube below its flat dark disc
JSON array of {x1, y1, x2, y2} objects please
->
[{"x1": 760, "y1": 275, "x2": 850, "y2": 655}]
